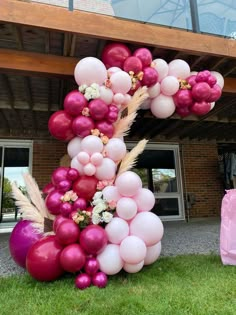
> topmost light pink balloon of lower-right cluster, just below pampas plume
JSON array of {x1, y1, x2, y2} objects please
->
[{"x1": 115, "y1": 171, "x2": 142, "y2": 197}]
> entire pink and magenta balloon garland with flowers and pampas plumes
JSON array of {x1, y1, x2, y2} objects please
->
[{"x1": 10, "y1": 43, "x2": 223, "y2": 289}]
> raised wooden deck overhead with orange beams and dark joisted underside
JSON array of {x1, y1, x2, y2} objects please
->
[{"x1": 0, "y1": 0, "x2": 236, "y2": 142}]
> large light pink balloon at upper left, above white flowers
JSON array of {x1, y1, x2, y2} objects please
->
[{"x1": 74, "y1": 57, "x2": 107, "y2": 86}]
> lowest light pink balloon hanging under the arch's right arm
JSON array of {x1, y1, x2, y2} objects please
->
[{"x1": 150, "y1": 94, "x2": 175, "y2": 118}]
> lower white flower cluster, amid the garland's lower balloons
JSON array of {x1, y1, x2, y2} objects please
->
[{"x1": 92, "y1": 192, "x2": 113, "y2": 224}]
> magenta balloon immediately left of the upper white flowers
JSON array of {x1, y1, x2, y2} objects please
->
[{"x1": 64, "y1": 90, "x2": 88, "y2": 116}]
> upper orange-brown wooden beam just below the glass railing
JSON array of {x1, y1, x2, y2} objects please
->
[{"x1": 0, "y1": 0, "x2": 236, "y2": 58}]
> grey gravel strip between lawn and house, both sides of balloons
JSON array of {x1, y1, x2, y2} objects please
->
[{"x1": 0, "y1": 218, "x2": 220, "y2": 277}]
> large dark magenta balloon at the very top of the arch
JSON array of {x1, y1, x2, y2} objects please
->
[{"x1": 102, "y1": 43, "x2": 131, "y2": 69}]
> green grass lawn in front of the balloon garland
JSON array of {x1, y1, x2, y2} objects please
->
[{"x1": 0, "y1": 255, "x2": 236, "y2": 315}]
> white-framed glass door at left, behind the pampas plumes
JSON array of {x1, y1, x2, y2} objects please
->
[{"x1": 0, "y1": 141, "x2": 32, "y2": 225}]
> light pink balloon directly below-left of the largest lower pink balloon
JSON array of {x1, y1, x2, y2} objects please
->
[{"x1": 120, "y1": 235, "x2": 147, "y2": 264}]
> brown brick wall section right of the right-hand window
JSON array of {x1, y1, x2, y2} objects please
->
[{"x1": 181, "y1": 143, "x2": 224, "y2": 217}]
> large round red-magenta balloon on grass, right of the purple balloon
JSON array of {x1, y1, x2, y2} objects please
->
[{"x1": 26, "y1": 235, "x2": 64, "y2": 281}]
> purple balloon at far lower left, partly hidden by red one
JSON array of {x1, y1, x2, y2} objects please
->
[{"x1": 9, "y1": 220, "x2": 43, "y2": 268}]
